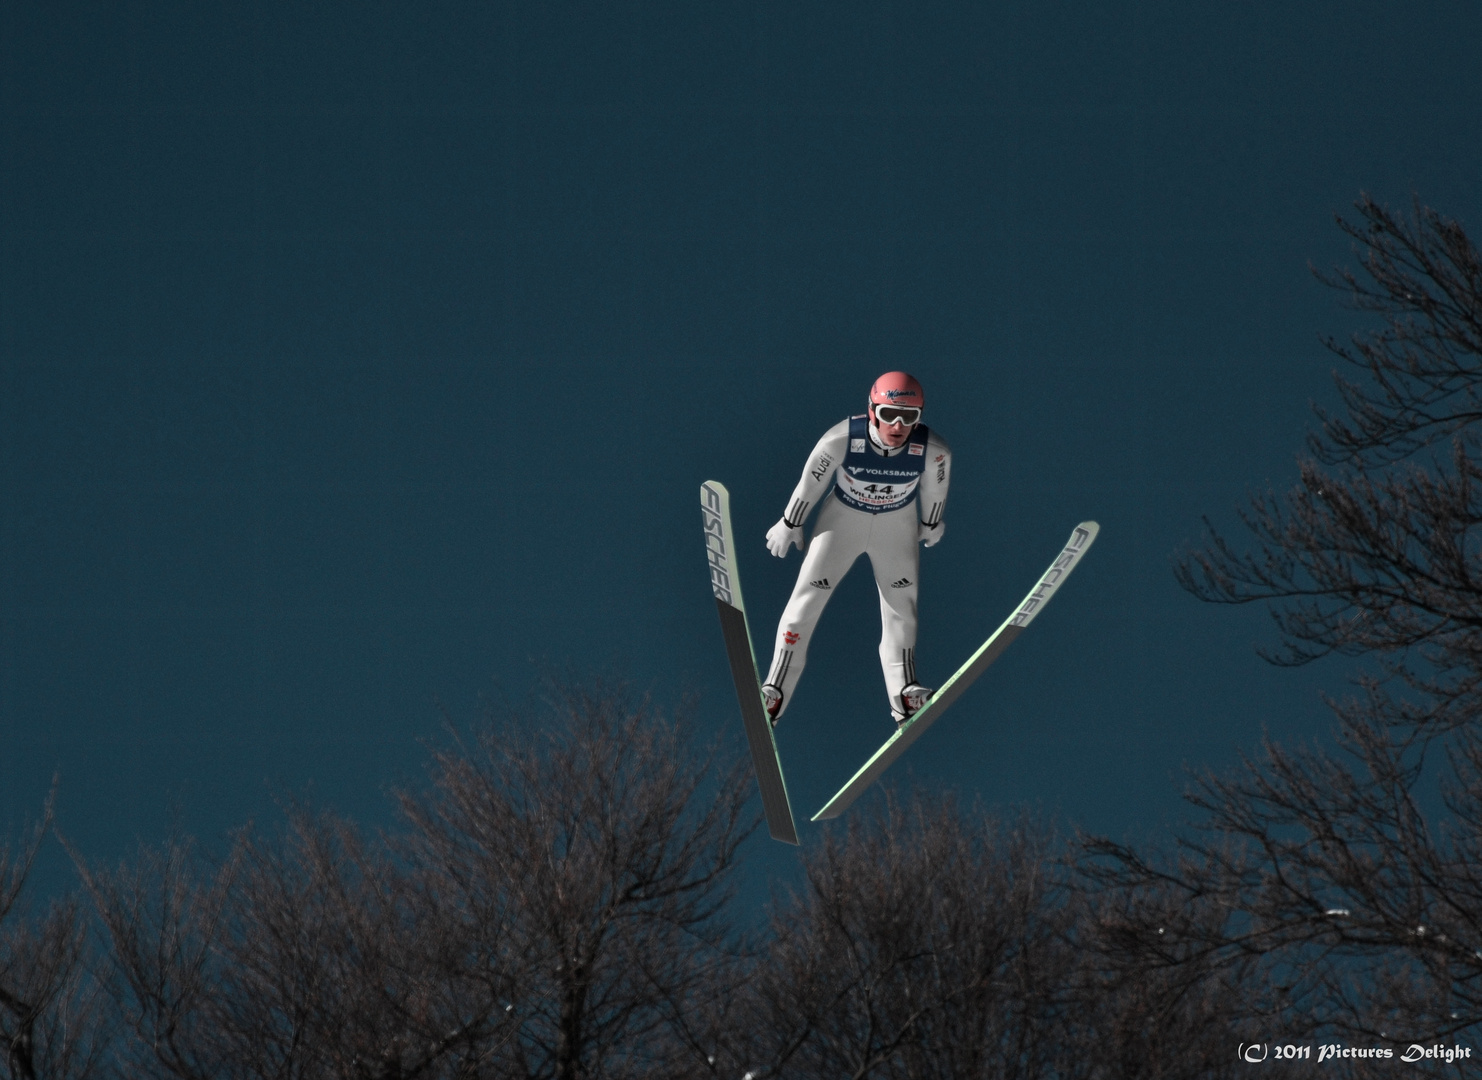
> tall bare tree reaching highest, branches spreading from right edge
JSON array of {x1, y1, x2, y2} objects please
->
[{"x1": 1089, "y1": 197, "x2": 1482, "y2": 1054}]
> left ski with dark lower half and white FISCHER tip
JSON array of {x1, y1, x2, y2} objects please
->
[{"x1": 700, "y1": 480, "x2": 797, "y2": 844}]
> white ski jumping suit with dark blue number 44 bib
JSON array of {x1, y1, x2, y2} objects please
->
[{"x1": 766, "y1": 415, "x2": 951, "y2": 719}]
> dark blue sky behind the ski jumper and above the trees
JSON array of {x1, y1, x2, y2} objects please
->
[{"x1": 0, "y1": 0, "x2": 1482, "y2": 888}]
